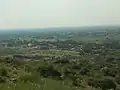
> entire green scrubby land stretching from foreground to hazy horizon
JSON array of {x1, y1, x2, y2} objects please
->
[{"x1": 0, "y1": 27, "x2": 120, "y2": 90}]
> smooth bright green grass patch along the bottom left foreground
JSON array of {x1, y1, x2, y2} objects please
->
[{"x1": 0, "y1": 79, "x2": 75, "y2": 90}]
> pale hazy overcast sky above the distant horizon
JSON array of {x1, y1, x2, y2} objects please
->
[{"x1": 0, "y1": 0, "x2": 120, "y2": 28}]
